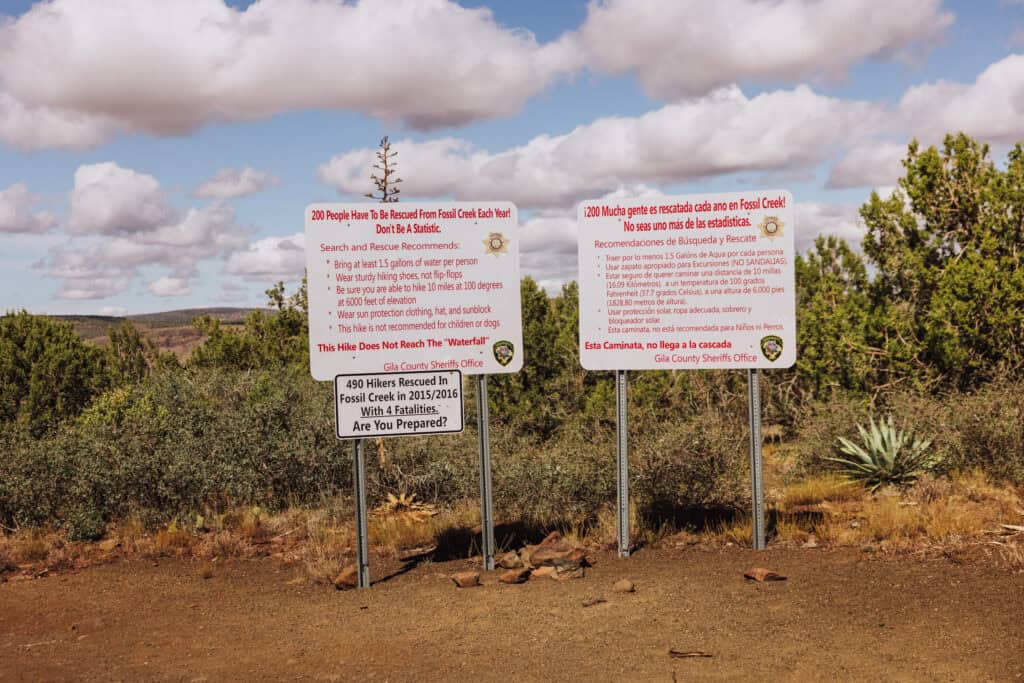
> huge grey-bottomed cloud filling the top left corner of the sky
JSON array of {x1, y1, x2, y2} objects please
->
[{"x1": 0, "y1": 0, "x2": 580, "y2": 148}]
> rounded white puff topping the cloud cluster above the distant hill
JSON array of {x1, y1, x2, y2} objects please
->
[{"x1": 68, "y1": 162, "x2": 173, "y2": 234}]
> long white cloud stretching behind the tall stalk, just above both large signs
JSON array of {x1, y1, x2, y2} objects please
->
[{"x1": 319, "y1": 86, "x2": 885, "y2": 208}]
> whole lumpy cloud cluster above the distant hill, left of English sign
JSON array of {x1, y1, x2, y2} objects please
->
[{"x1": 40, "y1": 162, "x2": 248, "y2": 299}]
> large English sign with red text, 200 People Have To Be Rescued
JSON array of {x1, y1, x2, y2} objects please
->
[{"x1": 306, "y1": 202, "x2": 522, "y2": 381}]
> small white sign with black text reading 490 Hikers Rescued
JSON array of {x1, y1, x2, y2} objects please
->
[{"x1": 334, "y1": 370, "x2": 463, "y2": 438}]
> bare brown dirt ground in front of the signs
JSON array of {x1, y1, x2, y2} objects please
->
[{"x1": 0, "y1": 547, "x2": 1024, "y2": 682}]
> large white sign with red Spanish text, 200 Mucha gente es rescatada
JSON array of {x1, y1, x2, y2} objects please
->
[{"x1": 579, "y1": 190, "x2": 797, "y2": 370}]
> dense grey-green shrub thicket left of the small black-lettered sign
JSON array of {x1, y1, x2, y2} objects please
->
[{"x1": 0, "y1": 370, "x2": 351, "y2": 532}]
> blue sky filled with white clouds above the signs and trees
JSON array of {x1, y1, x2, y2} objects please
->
[{"x1": 0, "y1": 0, "x2": 1024, "y2": 313}]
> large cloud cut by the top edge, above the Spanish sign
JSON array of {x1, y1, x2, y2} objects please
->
[{"x1": 565, "y1": 0, "x2": 953, "y2": 99}]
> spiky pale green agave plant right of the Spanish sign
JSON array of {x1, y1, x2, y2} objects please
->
[{"x1": 825, "y1": 416, "x2": 936, "y2": 493}]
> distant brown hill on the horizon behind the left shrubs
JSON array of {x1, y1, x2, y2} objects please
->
[{"x1": 50, "y1": 307, "x2": 273, "y2": 358}]
